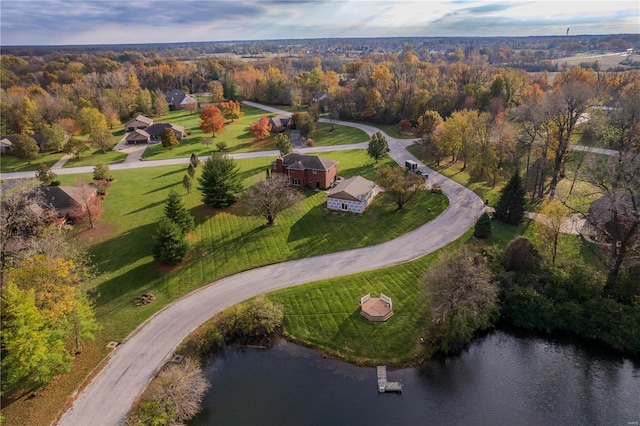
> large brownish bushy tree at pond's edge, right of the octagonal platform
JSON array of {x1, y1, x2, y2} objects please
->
[{"x1": 422, "y1": 246, "x2": 498, "y2": 353}]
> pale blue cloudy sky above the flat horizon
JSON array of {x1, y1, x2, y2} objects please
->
[{"x1": 0, "y1": 0, "x2": 640, "y2": 46}]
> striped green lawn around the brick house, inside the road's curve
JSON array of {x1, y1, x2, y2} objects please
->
[{"x1": 3, "y1": 150, "x2": 447, "y2": 424}]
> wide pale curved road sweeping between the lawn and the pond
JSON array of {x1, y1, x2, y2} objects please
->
[{"x1": 59, "y1": 106, "x2": 484, "y2": 426}]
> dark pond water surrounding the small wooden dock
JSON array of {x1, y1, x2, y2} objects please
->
[{"x1": 189, "y1": 331, "x2": 640, "y2": 426}]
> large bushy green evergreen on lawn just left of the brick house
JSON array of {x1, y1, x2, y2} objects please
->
[{"x1": 198, "y1": 156, "x2": 243, "y2": 207}]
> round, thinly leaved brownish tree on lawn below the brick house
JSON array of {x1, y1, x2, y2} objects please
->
[{"x1": 244, "y1": 175, "x2": 304, "y2": 226}]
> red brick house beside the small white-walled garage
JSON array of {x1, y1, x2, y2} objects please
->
[{"x1": 271, "y1": 152, "x2": 338, "y2": 189}]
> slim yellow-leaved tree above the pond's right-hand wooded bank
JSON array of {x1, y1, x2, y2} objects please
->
[{"x1": 533, "y1": 200, "x2": 571, "y2": 265}]
